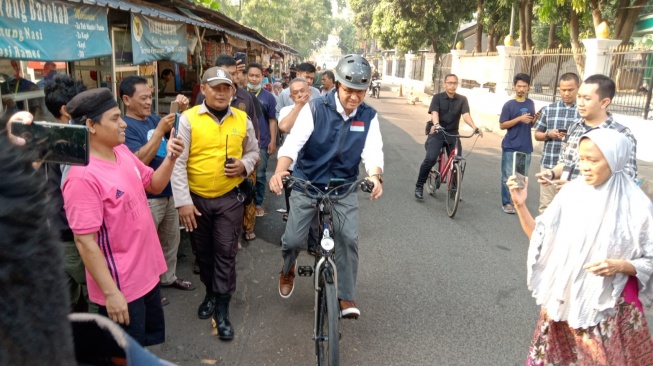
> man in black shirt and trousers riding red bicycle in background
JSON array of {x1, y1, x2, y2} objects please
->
[{"x1": 415, "y1": 74, "x2": 483, "y2": 200}]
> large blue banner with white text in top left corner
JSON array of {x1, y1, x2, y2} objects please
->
[{"x1": 0, "y1": 0, "x2": 111, "y2": 61}]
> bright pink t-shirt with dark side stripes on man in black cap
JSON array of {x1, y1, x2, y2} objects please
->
[{"x1": 63, "y1": 145, "x2": 167, "y2": 305}]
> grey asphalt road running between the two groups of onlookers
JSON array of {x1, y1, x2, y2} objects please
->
[{"x1": 150, "y1": 92, "x2": 636, "y2": 366}]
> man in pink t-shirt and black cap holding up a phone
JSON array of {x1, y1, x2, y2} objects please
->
[{"x1": 63, "y1": 88, "x2": 184, "y2": 346}]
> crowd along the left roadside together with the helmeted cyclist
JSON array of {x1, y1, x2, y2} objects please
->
[{"x1": 1, "y1": 54, "x2": 383, "y2": 364}]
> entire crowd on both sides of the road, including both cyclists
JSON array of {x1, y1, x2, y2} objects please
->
[{"x1": 0, "y1": 47, "x2": 653, "y2": 365}]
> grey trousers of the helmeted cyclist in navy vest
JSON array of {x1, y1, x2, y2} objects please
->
[{"x1": 281, "y1": 191, "x2": 358, "y2": 300}]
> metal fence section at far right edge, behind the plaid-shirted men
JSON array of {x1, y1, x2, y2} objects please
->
[{"x1": 604, "y1": 46, "x2": 653, "y2": 119}]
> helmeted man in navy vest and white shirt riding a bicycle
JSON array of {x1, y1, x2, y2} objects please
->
[{"x1": 270, "y1": 55, "x2": 383, "y2": 318}]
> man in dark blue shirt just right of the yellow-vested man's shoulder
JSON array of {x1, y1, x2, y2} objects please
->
[{"x1": 245, "y1": 62, "x2": 278, "y2": 217}]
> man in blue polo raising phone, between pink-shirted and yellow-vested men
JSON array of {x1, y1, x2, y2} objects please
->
[{"x1": 120, "y1": 76, "x2": 195, "y2": 305}]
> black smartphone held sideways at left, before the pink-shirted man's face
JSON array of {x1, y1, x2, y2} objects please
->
[{"x1": 11, "y1": 121, "x2": 89, "y2": 165}]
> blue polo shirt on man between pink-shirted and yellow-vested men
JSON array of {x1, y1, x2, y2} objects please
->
[{"x1": 122, "y1": 114, "x2": 172, "y2": 198}]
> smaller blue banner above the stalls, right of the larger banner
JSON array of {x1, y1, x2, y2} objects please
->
[{"x1": 132, "y1": 13, "x2": 188, "y2": 65}]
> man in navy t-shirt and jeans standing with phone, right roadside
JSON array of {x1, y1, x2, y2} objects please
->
[{"x1": 499, "y1": 73, "x2": 535, "y2": 214}]
